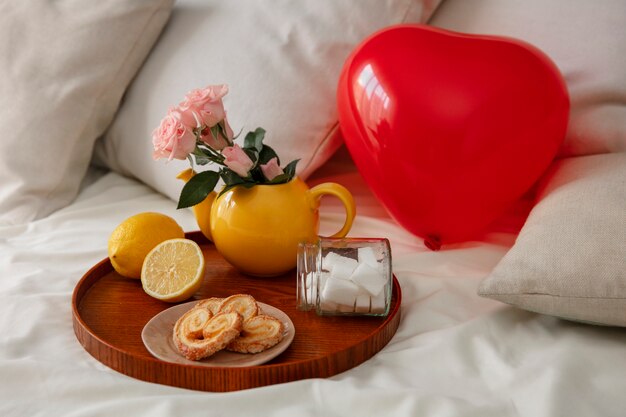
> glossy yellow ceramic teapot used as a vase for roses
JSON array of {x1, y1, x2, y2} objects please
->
[{"x1": 178, "y1": 169, "x2": 356, "y2": 276}]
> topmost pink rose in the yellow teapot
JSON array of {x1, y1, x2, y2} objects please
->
[{"x1": 178, "y1": 84, "x2": 228, "y2": 128}]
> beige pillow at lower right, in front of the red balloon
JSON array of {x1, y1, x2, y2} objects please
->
[{"x1": 478, "y1": 153, "x2": 626, "y2": 326}]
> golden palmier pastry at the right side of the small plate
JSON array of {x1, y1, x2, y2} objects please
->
[{"x1": 226, "y1": 314, "x2": 285, "y2": 353}]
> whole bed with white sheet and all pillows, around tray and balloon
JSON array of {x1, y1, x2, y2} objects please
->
[{"x1": 0, "y1": 0, "x2": 626, "y2": 417}]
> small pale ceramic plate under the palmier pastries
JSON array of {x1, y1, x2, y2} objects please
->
[{"x1": 141, "y1": 300, "x2": 296, "y2": 367}]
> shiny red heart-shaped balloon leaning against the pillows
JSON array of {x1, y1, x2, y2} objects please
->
[{"x1": 337, "y1": 25, "x2": 569, "y2": 249}]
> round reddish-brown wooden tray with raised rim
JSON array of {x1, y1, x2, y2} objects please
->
[{"x1": 72, "y1": 232, "x2": 401, "y2": 391}]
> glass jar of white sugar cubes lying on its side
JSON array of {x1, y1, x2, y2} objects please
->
[{"x1": 296, "y1": 238, "x2": 393, "y2": 316}]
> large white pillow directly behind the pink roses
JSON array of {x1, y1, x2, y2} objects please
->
[{"x1": 95, "y1": 0, "x2": 439, "y2": 200}]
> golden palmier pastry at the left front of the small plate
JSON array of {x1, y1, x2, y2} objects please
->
[{"x1": 173, "y1": 307, "x2": 243, "y2": 361}]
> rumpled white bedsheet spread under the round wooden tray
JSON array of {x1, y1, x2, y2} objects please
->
[{"x1": 0, "y1": 154, "x2": 626, "y2": 417}]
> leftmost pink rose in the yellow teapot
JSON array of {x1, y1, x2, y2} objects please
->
[{"x1": 152, "y1": 109, "x2": 196, "y2": 161}]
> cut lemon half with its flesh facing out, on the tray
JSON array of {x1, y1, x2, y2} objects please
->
[{"x1": 141, "y1": 239, "x2": 204, "y2": 303}]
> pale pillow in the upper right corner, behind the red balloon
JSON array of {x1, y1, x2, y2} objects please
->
[{"x1": 430, "y1": 0, "x2": 626, "y2": 156}]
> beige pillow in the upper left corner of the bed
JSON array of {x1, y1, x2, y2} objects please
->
[{"x1": 0, "y1": 0, "x2": 172, "y2": 225}]
